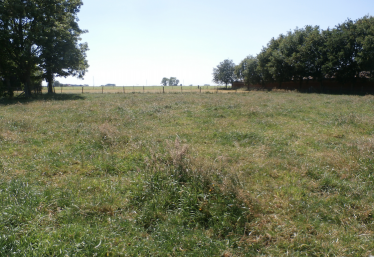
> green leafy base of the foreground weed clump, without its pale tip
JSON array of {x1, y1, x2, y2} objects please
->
[{"x1": 130, "y1": 172, "x2": 252, "y2": 238}]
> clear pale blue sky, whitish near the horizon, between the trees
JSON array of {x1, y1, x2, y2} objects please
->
[{"x1": 56, "y1": 0, "x2": 374, "y2": 86}]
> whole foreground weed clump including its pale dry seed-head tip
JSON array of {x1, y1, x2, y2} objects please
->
[{"x1": 130, "y1": 138, "x2": 254, "y2": 239}]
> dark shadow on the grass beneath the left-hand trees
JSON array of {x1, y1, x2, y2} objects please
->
[{"x1": 0, "y1": 94, "x2": 86, "y2": 105}]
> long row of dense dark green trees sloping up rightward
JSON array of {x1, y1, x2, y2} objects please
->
[{"x1": 213, "y1": 15, "x2": 374, "y2": 89}]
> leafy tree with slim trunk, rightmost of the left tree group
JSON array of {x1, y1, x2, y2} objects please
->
[{"x1": 38, "y1": 0, "x2": 88, "y2": 93}]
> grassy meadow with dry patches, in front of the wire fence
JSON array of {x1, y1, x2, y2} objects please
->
[{"x1": 0, "y1": 92, "x2": 374, "y2": 257}]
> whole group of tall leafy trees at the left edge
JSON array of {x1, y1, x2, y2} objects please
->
[{"x1": 0, "y1": 0, "x2": 88, "y2": 97}]
